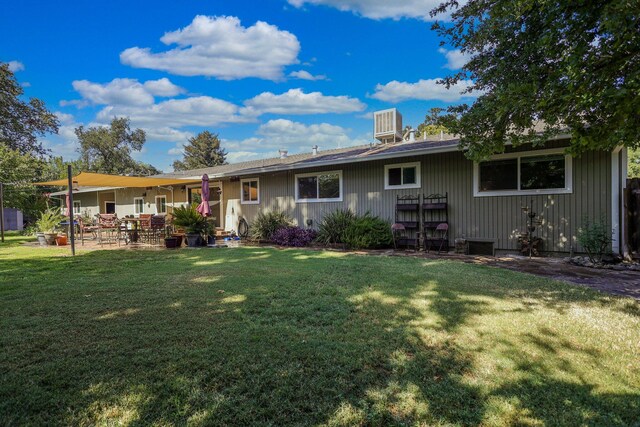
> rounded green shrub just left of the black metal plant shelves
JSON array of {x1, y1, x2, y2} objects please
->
[{"x1": 344, "y1": 212, "x2": 393, "y2": 249}]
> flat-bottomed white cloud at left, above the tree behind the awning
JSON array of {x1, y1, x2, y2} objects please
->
[{"x1": 70, "y1": 78, "x2": 184, "y2": 106}]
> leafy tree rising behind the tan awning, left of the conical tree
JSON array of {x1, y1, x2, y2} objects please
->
[{"x1": 75, "y1": 117, "x2": 160, "y2": 175}]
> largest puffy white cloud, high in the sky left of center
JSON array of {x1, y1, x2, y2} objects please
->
[{"x1": 120, "y1": 15, "x2": 300, "y2": 80}]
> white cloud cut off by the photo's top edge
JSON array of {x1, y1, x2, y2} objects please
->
[{"x1": 287, "y1": 0, "x2": 441, "y2": 21}]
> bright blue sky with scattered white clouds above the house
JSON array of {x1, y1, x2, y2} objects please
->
[{"x1": 0, "y1": 0, "x2": 470, "y2": 171}]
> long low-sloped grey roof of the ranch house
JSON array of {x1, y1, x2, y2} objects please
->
[{"x1": 156, "y1": 139, "x2": 459, "y2": 180}]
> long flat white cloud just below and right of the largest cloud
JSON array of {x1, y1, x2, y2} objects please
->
[{"x1": 242, "y1": 89, "x2": 366, "y2": 116}]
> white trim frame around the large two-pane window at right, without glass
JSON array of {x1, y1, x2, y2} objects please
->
[{"x1": 473, "y1": 148, "x2": 573, "y2": 197}]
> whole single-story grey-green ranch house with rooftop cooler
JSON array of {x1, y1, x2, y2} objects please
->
[{"x1": 53, "y1": 109, "x2": 627, "y2": 255}]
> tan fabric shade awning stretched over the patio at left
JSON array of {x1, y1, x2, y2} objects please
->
[{"x1": 35, "y1": 172, "x2": 200, "y2": 188}]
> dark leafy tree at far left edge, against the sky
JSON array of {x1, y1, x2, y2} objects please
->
[{"x1": 0, "y1": 62, "x2": 59, "y2": 156}]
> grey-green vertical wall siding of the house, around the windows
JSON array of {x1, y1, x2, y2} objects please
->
[{"x1": 232, "y1": 150, "x2": 611, "y2": 252}]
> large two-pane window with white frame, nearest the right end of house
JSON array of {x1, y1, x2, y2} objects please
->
[{"x1": 474, "y1": 149, "x2": 572, "y2": 196}]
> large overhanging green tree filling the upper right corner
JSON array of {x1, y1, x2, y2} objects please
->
[{"x1": 431, "y1": 0, "x2": 640, "y2": 159}]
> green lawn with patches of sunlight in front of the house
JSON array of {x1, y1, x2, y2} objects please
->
[{"x1": 0, "y1": 237, "x2": 640, "y2": 426}]
